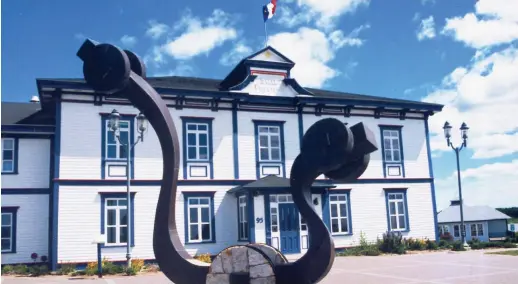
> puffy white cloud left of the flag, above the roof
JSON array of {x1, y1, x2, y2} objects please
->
[{"x1": 163, "y1": 9, "x2": 237, "y2": 59}]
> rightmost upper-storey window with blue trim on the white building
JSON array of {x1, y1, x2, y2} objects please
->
[{"x1": 380, "y1": 125, "x2": 405, "y2": 177}]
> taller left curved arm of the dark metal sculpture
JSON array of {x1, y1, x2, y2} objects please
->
[{"x1": 78, "y1": 40, "x2": 209, "y2": 284}]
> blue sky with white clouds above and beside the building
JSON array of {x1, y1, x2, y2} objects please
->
[{"x1": 1, "y1": 0, "x2": 518, "y2": 210}]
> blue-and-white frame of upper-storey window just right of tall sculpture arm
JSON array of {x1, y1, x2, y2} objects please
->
[{"x1": 180, "y1": 116, "x2": 214, "y2": 179}]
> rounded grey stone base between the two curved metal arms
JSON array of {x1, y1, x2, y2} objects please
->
[{"x1": 206, "y1": 244, "x2": 288, "y2": 284}]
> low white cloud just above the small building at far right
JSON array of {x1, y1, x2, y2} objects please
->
[{"x1": 435, "y1": 160, "x2": 518, "y2": 210}]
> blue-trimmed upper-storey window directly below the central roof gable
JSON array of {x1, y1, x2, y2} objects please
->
[{"x1": 254, "y1": 120, "x2": 286, "y2": 179}]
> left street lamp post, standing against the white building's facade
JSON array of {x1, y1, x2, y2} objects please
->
[{"x1": 109, "y1": 109, "x2": 147, "y2": 269}]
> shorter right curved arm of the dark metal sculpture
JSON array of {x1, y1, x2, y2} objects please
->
[{"x1": 276, "y1": 118, "x2": 377, "y2": 283}]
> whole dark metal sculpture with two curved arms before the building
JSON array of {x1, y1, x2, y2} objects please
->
[{"x1": 77, "y1": 40, "x2": 377, "y2": 284}]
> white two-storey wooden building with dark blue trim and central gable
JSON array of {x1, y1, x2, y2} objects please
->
[{"x1": 2, "y1": 47, "x2": 442, "y2": 269}]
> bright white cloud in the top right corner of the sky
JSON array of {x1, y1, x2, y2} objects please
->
[{"x1": 441, "y1": 0, "x2": 518, "y2": 48}]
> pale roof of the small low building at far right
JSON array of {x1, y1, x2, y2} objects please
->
[{"x1": 437, "y1": 205, "x2": 511, "y2": 223}]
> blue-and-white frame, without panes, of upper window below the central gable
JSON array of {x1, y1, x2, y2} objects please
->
[{"x1": 252, "y1": 120, "x2": 286, "y2": 179}]
